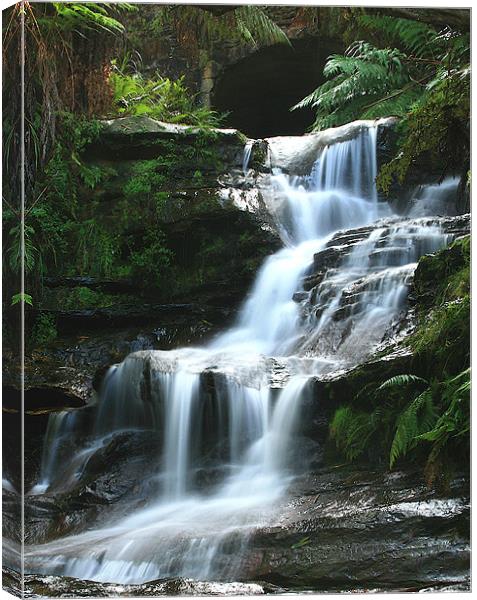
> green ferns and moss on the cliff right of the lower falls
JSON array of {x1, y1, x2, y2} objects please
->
[{"x1": 330, "y1": 236, "x2": 470, "y2": 484}]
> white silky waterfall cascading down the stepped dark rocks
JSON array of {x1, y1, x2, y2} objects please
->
[{"x1": 26, "y1": 122, "x2": 456, "y2": 583}]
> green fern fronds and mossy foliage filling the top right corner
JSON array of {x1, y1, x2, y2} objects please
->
[{"x1": 292, "y1": 13, "x2": 470, "y2": 193}]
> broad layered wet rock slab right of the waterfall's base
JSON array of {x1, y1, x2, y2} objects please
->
[{"x1": 245, "y1": 468, "x2": 470, "y2": 592}]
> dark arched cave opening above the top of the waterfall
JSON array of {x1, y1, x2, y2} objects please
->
[{"x1": 212, "y1": 38, "x2": 340, "y2": 138}]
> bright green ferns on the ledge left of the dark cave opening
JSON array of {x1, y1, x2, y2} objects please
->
[{"x1": 109, "y1": 61, "x2": 222, "y2": 128}]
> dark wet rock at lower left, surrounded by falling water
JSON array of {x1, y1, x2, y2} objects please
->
[{"x1": 21, "y1": 431, "x2": 163, "y2": 543}]
